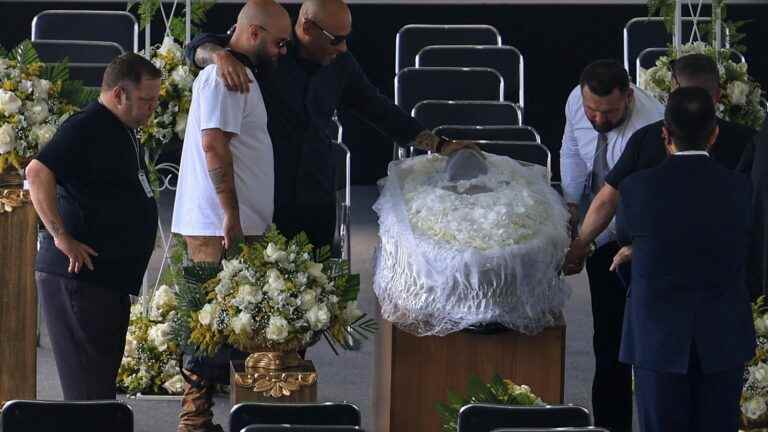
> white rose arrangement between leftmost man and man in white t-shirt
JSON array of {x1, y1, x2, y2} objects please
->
[{"x1": 138, "y1": 36, "x2": 197, "y2": 181}]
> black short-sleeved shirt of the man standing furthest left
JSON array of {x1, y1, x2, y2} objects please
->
[{"x1": 36, "y1": 102, "x2": 157, "y2": 295}]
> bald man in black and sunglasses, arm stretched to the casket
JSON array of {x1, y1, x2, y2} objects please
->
[{"x1": 187, "y1": 0, "x2": 458, "y2": 250}]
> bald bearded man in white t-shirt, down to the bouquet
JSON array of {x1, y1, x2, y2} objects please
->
[{"x1": 171, "y1": 0, "x2": 291, "y2": 262}]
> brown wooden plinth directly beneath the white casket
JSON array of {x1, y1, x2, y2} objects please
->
[{"x1": 374, "y1": 320, "x2": 565, "y2": 432}]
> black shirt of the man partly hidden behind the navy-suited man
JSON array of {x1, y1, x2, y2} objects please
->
[{"x1": 605, "y1": 120, "x2": 757, "y2": 189}]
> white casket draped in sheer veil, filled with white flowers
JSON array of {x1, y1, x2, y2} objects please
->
[{"x1": 374, "y1": 153, "x2": 569, "y2": 336}]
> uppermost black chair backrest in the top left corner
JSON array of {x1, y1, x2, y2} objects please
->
[{"x1": 32, "y1": 10, "x2": 139, "y2": 51}]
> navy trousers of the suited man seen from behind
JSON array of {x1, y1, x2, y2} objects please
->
[{"x1": 635, "y1": 350, "x2": 744, "y2": 432}]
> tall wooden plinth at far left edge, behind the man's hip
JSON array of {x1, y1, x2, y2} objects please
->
[{"x1": 0, "y1": 203, "x2": 37, "y2": 406}]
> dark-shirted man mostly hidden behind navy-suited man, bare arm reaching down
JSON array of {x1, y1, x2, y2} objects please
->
[{"x1": 564, "y1": 54, "x2": 756, "y2": 274}]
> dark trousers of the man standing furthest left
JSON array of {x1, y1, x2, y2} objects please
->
[{"x1": 35, "y1": 272, "x2": 131, "y2": 400}]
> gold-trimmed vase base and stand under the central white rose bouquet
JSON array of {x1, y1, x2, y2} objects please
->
[{"x1": 229, "y1": 352, "x2": 317, "y2": 406}]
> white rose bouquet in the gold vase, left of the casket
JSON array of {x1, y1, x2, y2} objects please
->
[{"x1": 174, "y1": 226, "x2": 375, "y2": 355}]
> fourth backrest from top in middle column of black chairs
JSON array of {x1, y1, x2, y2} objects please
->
[{"x1": 411, "y1": 99, "x2": 520, "y2": 129}]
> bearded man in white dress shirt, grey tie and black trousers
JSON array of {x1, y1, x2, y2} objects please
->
[{"x1": 560, "y1": 60, "x2": 664, "y2": 432}]
